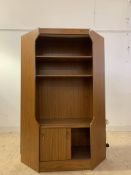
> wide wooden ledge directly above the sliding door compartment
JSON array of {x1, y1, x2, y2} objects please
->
[{"x1": 39, "y1": 118, "x2": 91, "y2": 128}]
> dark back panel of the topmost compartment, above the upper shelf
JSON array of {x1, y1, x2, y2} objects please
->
[{"x1": 36, "y1": 37, "x2": 92, "y2": 56}]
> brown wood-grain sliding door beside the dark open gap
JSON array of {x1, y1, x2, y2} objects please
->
[{"x1": 40, "y1": 128, "x2": 71, "y2": 161}]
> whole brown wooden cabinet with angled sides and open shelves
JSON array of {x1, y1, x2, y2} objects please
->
[{"x1": 21, "y1": 29, "x2": 106, "y2": 172}]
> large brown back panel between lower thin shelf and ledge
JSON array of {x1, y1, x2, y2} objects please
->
[{"x1": 36, "y1": 78, "x2": 92, "y2": 119}]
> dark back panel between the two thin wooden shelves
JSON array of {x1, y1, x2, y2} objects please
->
[{"x1": 37, "y1": 60, "x2": 92, "y2": 75}]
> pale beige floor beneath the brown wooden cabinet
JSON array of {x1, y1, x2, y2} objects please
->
[{"x1": 0, "y1": 132, "x2": 131, "y2": 175}]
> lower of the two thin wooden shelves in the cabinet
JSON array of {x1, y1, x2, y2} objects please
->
[{"x1": 36, "y1": 75, "x2": 92, "y2": 78}]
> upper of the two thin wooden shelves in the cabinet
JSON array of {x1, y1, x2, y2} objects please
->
[{"x1": 36, "y1": 55, "x2": 92, "y2": 61}]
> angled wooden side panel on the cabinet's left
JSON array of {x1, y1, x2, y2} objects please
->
[{"x1": 21, "y1": 31, "x2": 39, "y2": 171}]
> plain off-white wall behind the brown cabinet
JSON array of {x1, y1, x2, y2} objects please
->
[{"x1": 0, "y1": 0, "x2": 131, "y2": 131}]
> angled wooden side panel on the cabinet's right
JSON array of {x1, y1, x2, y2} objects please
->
[{"x1": 90, "y1": 31, "x2": 106, "y2": 168}]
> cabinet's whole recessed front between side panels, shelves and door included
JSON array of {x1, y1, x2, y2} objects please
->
[{"x1": 36, "y1": 35, "x2": 92, "y2": 161}]
